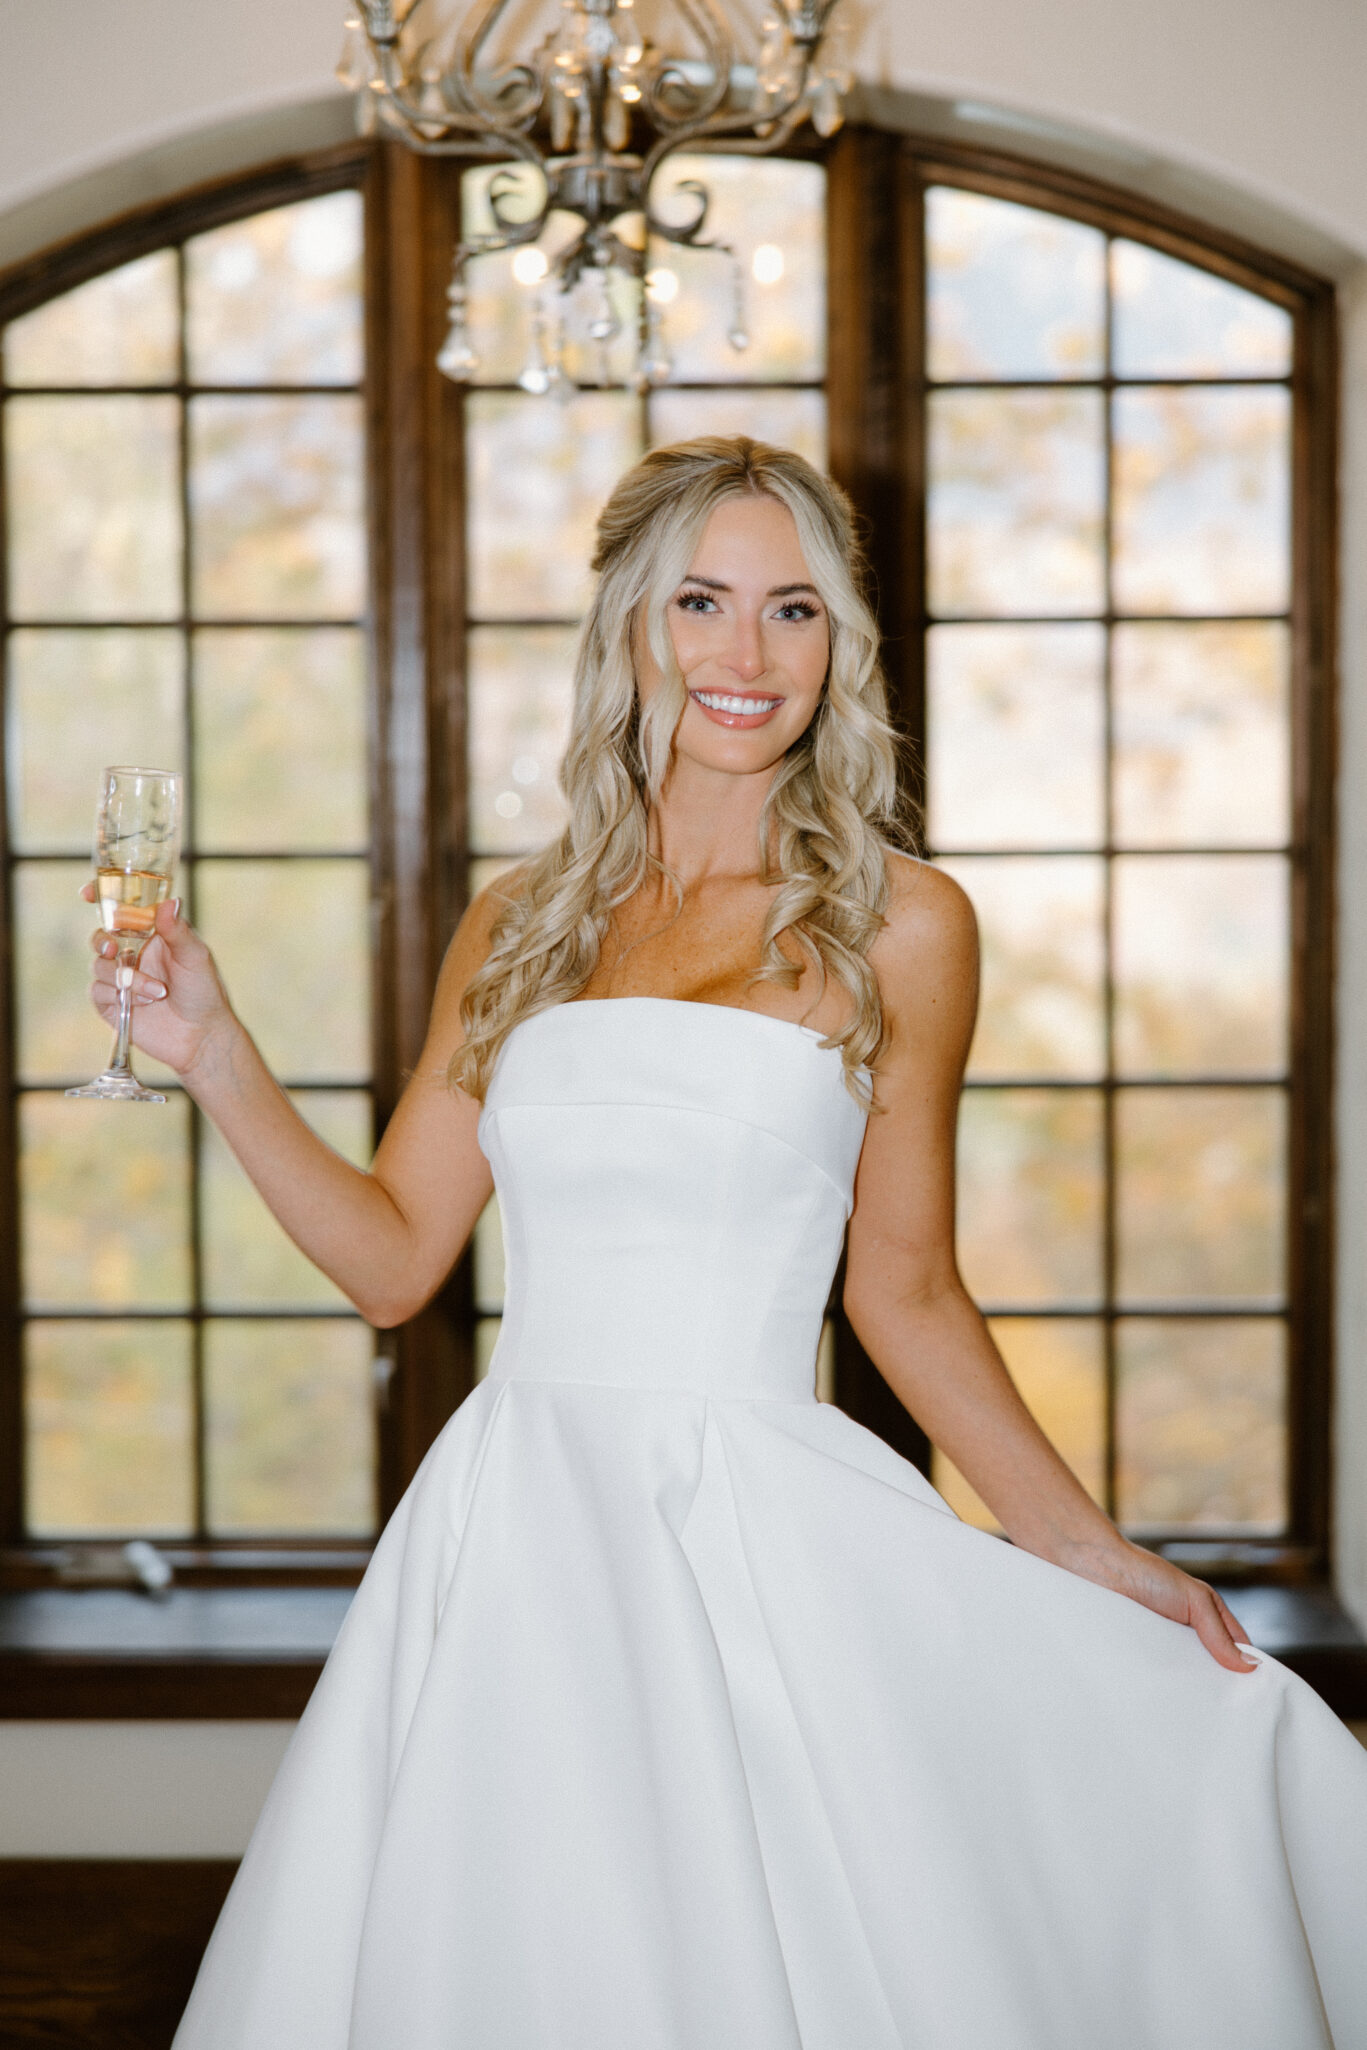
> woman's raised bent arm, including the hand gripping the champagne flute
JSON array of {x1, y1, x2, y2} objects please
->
[{"x1": 92, "y1": 884, "x2": 506, "y2": 1324}]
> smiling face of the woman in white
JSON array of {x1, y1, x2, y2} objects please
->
[{"x1": 635, "y1": 494, "x2": 830, "y2": 775}]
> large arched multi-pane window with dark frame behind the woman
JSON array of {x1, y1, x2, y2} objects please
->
[{"x1": 0, "y1": 131, "x2": 1332, "y2": 1607}]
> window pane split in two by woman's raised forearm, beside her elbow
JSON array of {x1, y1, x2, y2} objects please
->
[{"x1": 199, "y1": 1089, "x2": 371, "y2": 1310}]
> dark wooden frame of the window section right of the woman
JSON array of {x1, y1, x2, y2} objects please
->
[{"x1": 828, "y1": 127, "x2": 1338, "y2": 1583}]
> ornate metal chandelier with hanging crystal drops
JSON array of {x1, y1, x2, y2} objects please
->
[{"x1": 336, "y1": 0, "x2": 851, "y2": 394}]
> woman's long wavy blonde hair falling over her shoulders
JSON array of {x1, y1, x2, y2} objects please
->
[{"x1": 449, "y1": 435, "x2": 914, "y2": 1105}]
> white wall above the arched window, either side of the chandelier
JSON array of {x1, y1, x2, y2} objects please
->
[{"x1": 0, "y1": 0, "x2": 1367, "y2": 274}]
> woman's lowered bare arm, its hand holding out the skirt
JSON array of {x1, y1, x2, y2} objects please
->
[{"x1": 844, "y1": 859, "x2": 1254, "y2": 1671}]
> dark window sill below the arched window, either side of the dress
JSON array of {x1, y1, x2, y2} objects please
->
[{"x1": 0, "y1": 1587, "x2": 1367, "y2": 1722}]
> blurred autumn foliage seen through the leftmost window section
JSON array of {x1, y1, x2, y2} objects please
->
[{"x1": 0, "y1": 191, "x2": 375, "y2": 1540}]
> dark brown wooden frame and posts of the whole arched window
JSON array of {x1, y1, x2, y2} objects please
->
[{"x1": 0, "y1": 127, "x2": 1344, "y2": 1716}]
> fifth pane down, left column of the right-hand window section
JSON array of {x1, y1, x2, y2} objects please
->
[{"x1": 959, "y1": 1089, "x2": 1103, "y2": 1304}]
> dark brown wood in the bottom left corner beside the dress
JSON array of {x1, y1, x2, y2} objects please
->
[{"x1": 0, "y1": 1859, "x2": 236, "y2": 2050}]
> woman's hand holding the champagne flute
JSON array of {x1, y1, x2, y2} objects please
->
[{"x1": 80, "y1": 884, "x2": 240, "y2": 1080}]
